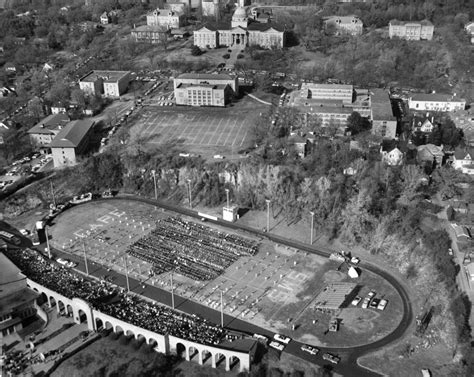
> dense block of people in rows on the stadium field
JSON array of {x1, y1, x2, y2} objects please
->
[{"x1": 127, "y1": 217, "x2": 258, "y2": 280}]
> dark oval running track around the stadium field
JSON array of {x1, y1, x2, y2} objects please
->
[{"x1": 3, "y1": 196, "x2": 413, "y2": 376}]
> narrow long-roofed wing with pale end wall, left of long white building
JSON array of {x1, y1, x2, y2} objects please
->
[{"x1": 370, "y1": 89, "x2": 397, "y2": 139}]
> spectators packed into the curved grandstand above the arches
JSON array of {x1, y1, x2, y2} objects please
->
[{"x1": 5, "y1": 249, "x2": 228, "y2": 345}]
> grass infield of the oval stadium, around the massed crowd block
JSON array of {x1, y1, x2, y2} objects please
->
[{"x1": 50, "y1": 200, "x2": 401, "y2": 346}]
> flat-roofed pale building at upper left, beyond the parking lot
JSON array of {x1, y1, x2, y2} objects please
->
[{"x1": 79, "y1": 71, "x2": 130, "y2": 97}]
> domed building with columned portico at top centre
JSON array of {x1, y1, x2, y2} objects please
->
[{"x1": 194, "y1": 1, "x2": 285, "y2": 48}]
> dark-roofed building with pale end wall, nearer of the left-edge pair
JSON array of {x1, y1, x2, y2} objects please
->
[{"x1": 50, "y1": 119, "x2": 95, "y2": 168}]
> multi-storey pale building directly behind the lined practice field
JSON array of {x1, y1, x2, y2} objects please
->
[{"x1": 174, "y1": 73, "x2": 239, "y2": 107}]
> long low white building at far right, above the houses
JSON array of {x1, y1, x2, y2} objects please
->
[{"x1": 408, "y1": 93, "x2": 466, "y2": 112}]
